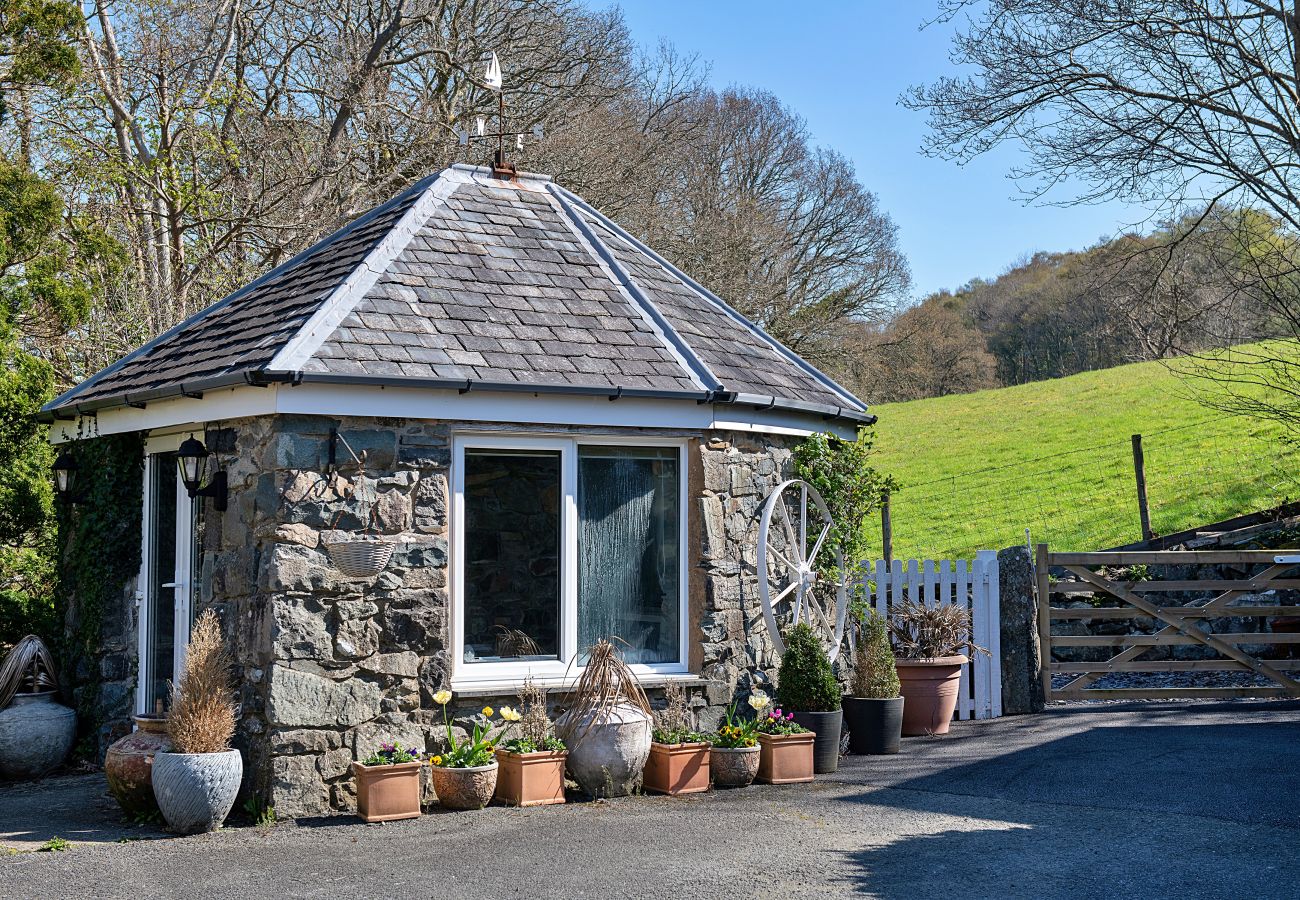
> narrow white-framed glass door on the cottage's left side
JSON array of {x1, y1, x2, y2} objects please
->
[{"x1": 135, "y1": 450, "x2": 195, "y2": 713}]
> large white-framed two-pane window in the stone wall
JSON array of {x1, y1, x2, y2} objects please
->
[{"x1": 452, "y1": 436, "x2": 686, "y2": 682}]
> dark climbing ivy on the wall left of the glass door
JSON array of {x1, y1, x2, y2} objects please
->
[{"x1": 57, "y1": 434, "x2": 144, "y2": 736}]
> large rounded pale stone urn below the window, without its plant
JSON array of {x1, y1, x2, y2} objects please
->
[{"x1": 555, "y1": 705, "x2": 650, "y2": 797}]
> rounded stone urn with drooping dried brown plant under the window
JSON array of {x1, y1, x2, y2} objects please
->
[{"x1": 555, "y1": 640, "x2": 653, "y2": 797}]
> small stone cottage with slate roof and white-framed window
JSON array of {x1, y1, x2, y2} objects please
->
[{"x1": 44, "y1": 165, "x2": 872, "y2": 815}]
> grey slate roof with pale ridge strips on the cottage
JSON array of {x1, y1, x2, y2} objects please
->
[{"x1": 46, "y1": 165, "x2": 867, "y2": 420}]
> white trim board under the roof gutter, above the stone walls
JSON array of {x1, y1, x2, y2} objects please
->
[{"x1": 49, "y1": 382, "x2": 855, "y2": 443}]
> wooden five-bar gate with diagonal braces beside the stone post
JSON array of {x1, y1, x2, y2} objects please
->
[{"x1": 1035, "y1": 544, "x2": 1300, "y2": 700}]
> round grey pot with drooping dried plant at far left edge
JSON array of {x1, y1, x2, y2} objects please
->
[{"x1": 0, "y1": 635, "x2": 77, "y2": 779}]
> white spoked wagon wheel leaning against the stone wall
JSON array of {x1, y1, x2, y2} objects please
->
[{"x1": 758, "y1": 479, "x2": 849, "y2": 659}]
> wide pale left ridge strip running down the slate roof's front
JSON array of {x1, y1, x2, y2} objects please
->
[{"x1": 267, "y1": 169, "x2": 465, "y2": 372}]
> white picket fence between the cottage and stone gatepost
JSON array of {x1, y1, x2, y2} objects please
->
[{"x1": 863, "y1": 550, "x2": 1002, "y2": 719}]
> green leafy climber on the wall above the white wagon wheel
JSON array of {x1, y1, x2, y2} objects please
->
[{"x1": 793, "y1": 428, "x2": 898, "y2": 579}]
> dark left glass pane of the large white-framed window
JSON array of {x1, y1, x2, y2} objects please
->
[{"x1": 464, "y1": 450, "x2": 562, "y2": 662}]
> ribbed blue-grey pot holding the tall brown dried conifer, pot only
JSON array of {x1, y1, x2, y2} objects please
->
[{"x1": 153, "y1": 750, "x2": 243, "y2": 835}]
